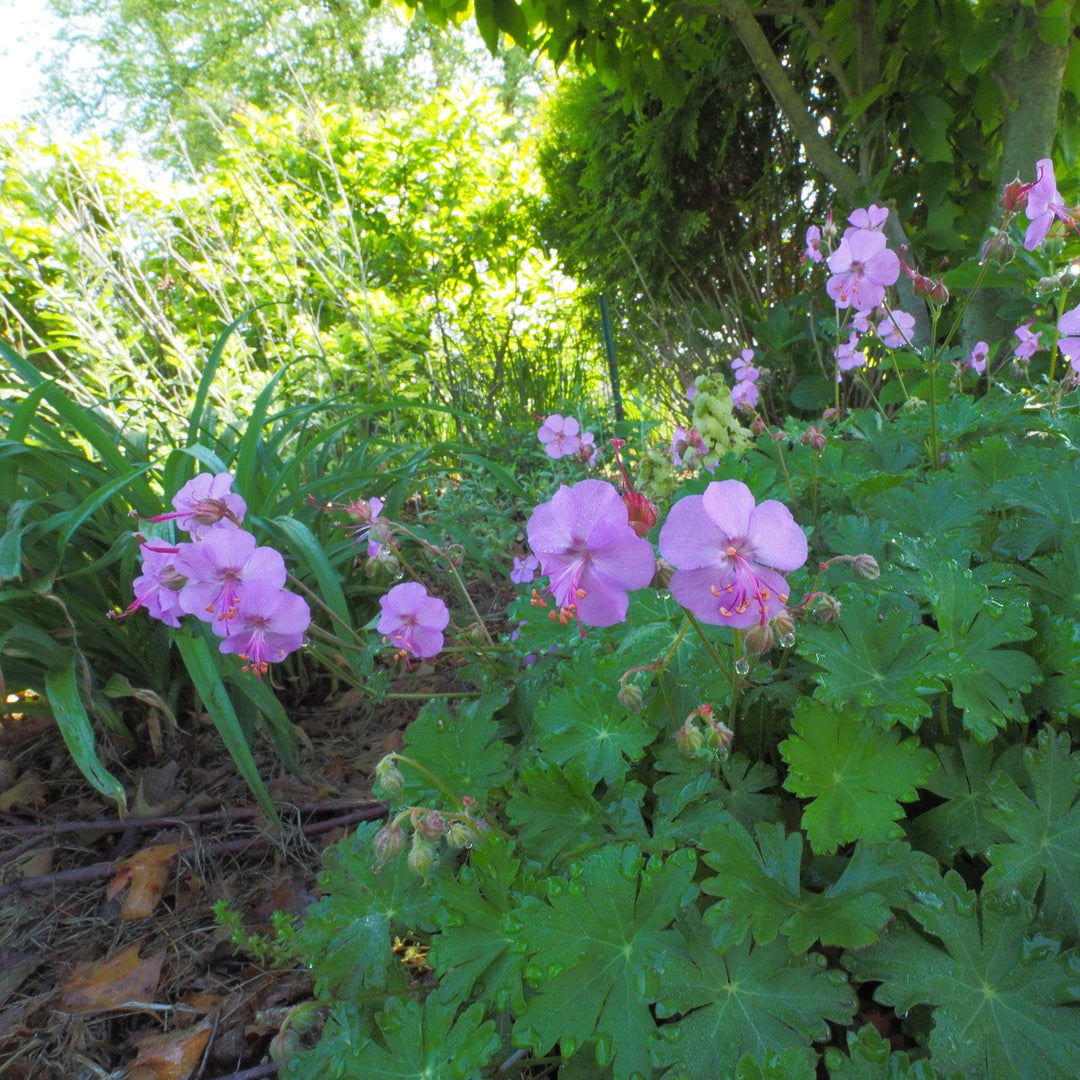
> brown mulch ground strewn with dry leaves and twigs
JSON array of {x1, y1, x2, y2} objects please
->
[{"x1": 0, "y1": 692, "x2": 414, "y2": 1080}]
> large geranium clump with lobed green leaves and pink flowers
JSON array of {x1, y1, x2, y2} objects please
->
[{"x1": 272, "y1": 162, "x2": 1080, "y2": 1080}]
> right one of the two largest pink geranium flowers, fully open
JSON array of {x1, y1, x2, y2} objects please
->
[{"x1": 660, "y1": 480, "x2": 807, "y2": 629}]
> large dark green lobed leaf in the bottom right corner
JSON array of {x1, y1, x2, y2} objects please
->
[{"x1": 846, "y1": 870, "x2": 1080, "y2": 1080}]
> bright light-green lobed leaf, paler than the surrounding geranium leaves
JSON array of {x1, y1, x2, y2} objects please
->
[{"x1": 780, "y1": 699, "x2": 937, "y2": 852}]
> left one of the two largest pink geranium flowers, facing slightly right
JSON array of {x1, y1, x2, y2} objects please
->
[{"x1": 526, "y1": 480, "x2": 656, "y2": 626}]
